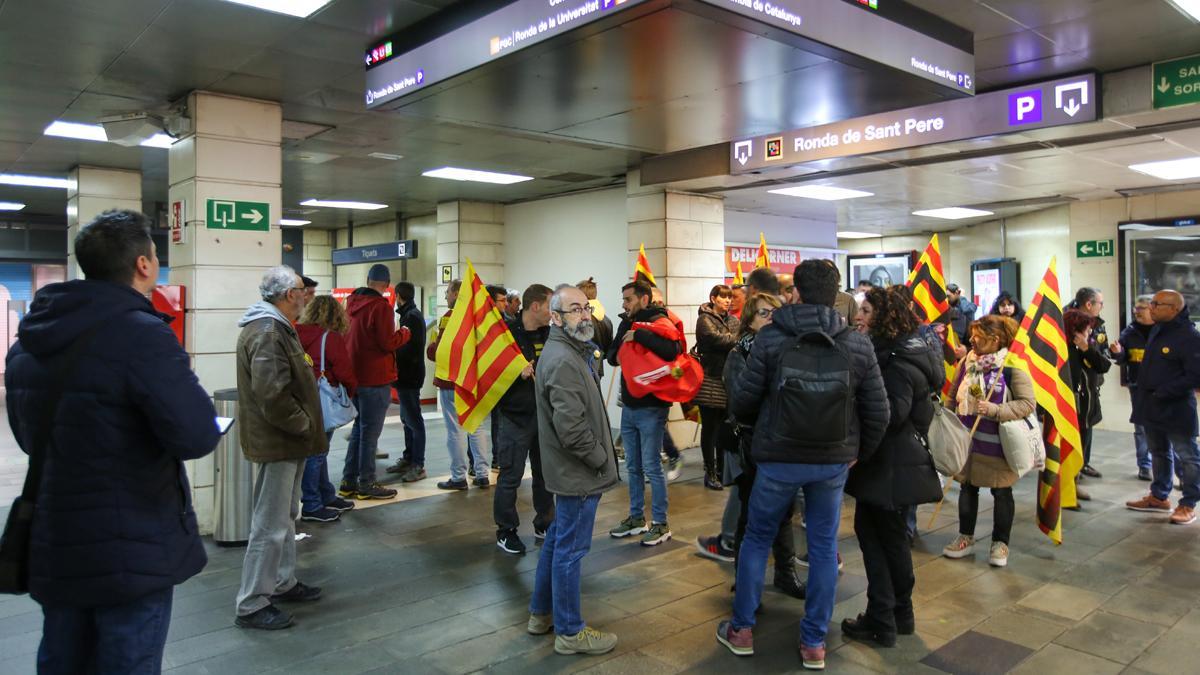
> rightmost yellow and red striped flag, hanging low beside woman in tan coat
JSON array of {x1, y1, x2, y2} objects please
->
[{"x1": 1008, "y1": 258, "x2": 1084, "y2": 544}]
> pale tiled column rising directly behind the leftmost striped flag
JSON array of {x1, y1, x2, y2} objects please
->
[{"x1": 437, "y1": 202, "x2": 504, "y2": 316}]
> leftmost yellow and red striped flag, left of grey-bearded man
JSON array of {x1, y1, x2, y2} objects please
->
[{"x1": 436, "y1": 259, "x2": 529, "y2": 434}]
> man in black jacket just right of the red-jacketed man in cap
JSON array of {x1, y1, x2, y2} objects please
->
[{"x1": 386, "y1": 281, "x2": 426, "y2": 483}]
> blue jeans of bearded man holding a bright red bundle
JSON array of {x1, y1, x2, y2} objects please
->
[{"x1": 620, "y1": 407, "x2": 670, "y2": 522}]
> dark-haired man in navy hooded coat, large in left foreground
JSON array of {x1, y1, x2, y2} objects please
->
[{"x1": 5, "y1": 211, "x2": 220, "y2": 674}]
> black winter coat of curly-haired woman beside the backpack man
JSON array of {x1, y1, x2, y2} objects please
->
[{"x1": 846, "y1": 333, "x2": 946, "y2": 509}]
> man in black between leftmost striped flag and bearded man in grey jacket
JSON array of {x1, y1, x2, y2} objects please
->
[{"x1": 492, "y1": 283, "x2": 554, "y2": 555}]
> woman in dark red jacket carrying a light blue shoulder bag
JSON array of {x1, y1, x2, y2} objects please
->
[{"x1": 296, "y1": 295, "x2": 358, "y2": 522}]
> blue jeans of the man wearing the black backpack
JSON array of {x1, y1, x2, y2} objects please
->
[{"x1": 734, "y1": 458, "x2": 850, "y2": 647}]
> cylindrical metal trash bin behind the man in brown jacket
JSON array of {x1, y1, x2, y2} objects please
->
[{"x1": 212, "y1": 389, "x2": 256, "y2": 546}]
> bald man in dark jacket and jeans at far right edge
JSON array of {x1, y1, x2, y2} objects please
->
[{"x1": 1126, "y1": 285, "x2": 1200, "y2": 525}]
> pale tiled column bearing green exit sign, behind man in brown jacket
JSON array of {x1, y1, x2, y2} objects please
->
[{"x1": 169, "y1": 91, "x2": 283, "y2": 532}]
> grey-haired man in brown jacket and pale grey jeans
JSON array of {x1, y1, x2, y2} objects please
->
[{"x1": 235, "y1": 265, "x2": 329, "y2": 631}]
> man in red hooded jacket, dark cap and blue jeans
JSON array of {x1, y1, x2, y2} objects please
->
[{"x1": 337, "y1": 263, "x2": 412, "y2": 500}]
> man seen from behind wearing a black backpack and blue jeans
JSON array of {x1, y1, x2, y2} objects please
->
[{"x1": 716, "y1": 259, "x2": 888, "y2": 670}]
